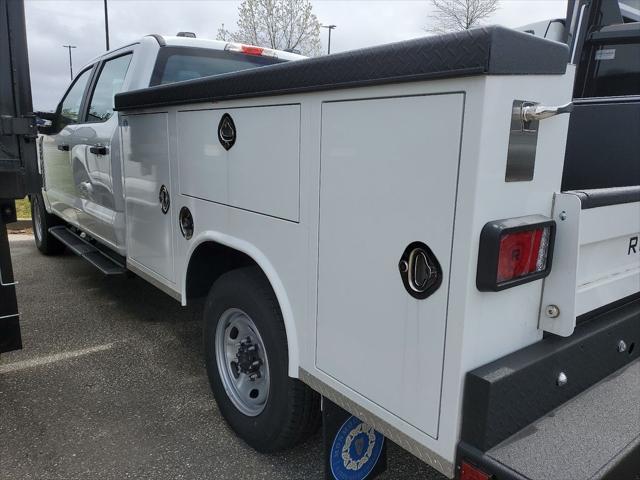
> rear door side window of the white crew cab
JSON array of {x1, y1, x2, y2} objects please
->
[{"x1": 87, "y1": 53, "x2": 131, "y2": 122}]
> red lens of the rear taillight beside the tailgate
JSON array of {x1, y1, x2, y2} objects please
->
[{"x1": 496, "y1": 227, "x2": 551, "y2": 283}]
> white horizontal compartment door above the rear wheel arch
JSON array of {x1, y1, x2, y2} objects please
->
[{"x1": 177, "y1": 105, "x2": 300, "y2": 222}]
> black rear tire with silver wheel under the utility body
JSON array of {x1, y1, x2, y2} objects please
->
[{"x1": 204, "y1": 267, "x2": 320, "y2": 453}]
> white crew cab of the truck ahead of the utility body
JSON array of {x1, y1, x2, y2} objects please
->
[{"x1": 32, "y1": 34, "x2": 304, "y2": 258}]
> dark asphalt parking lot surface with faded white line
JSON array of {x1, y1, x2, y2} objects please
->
[{"x1": 0, "y1": 235, "x2": 444, "y2": 480}]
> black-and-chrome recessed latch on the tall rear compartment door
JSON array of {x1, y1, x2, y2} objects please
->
[{"x1": 398, "y1": 242, "x2": 442, "y2": 300}]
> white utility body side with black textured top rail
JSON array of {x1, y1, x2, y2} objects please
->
[{"x1": 116, "y1": 30, "x2": 573, "y2": 477}]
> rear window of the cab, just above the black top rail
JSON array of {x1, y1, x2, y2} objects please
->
[{"x1": 150, "y1": 47, "x2": 284, "y2": 86}]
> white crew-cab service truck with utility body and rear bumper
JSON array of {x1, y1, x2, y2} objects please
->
[{"x1": 32, "y1": 2, "x2": 640, "y2": 480}]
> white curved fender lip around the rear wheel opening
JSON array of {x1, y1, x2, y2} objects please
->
[{"x1": 180, "y1": 230, "x2": 300, "y2": 378}]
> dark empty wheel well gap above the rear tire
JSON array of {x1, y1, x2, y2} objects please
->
[{"x1": 186, "y1": 242, "x2": 266, "y2": 299}]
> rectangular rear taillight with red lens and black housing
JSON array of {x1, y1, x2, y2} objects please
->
[{"x1": 476, "y1": 215, "x2": 556, "y2": 292}]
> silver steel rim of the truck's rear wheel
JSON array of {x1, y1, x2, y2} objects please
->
[{"x1": 215, "y1": 308, "x2": 269, "y2": 417}]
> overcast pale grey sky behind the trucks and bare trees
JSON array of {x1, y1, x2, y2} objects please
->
[{"x1": 25, "y1": 0, "x2": 567, "y2": 110}]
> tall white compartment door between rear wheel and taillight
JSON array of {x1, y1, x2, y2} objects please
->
[{"x1": 316, "y1": 93, "x2": 464, "y2": 437}]
